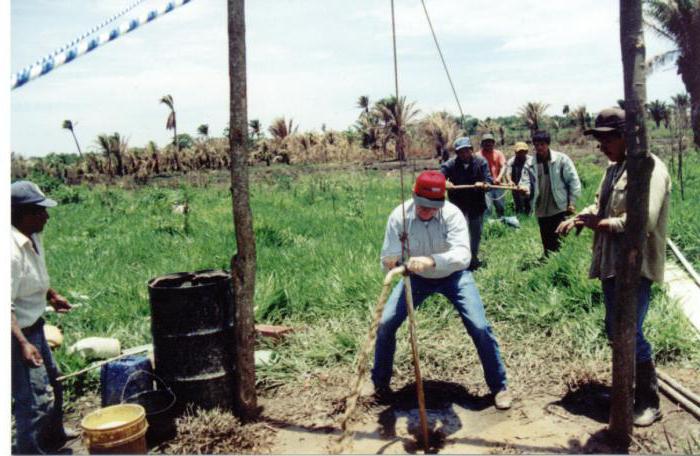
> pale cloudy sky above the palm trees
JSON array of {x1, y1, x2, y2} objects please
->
[{"x1": 8, "y1": 0, "x2": 685, "y2": 157}]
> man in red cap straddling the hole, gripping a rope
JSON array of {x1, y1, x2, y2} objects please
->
[{"x1": 372, "y1": 171, "x2": 512, "y2": 409}]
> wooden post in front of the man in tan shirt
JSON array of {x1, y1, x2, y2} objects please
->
[{"x1": 609, "y1": 0, "x2": 654, "y2": 452}]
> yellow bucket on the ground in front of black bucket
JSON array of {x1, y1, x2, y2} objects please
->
[{"x1": 80, "y1": 404, "x2": 148, "y2": 454}]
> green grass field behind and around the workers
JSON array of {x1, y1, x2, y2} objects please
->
[{"x1": 37, "y1": 148, "x2": 700, "y2": 404}]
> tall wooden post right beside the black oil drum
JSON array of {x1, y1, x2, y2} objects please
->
[{"x1": 228, "y1": 0, "x2": 259, "y2": 420}]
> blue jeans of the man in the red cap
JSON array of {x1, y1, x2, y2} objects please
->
[{"x1": 372, "y1": 270, "x2": 507, "y2": 393}]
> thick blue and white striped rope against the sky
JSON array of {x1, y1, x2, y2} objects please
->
[{"x1": 10, "y1": 0, "x2": 196, "y2": 90}]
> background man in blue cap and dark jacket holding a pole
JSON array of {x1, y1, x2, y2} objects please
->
[{"x1": 440, "y1": 136, "x2": 493, "y2": 271}]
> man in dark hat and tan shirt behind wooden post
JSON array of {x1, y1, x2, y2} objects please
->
[{"x1": 557, "y1": 108, "x2": 671, "y2": 426}]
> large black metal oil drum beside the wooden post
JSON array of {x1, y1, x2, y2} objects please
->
[{"x1": 148, "y1": 270, "x2": 234, "y2": 412}]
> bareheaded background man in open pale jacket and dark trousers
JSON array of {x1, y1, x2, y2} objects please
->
[{"x1": 520, "y1": 130, "x2": 581, "y2": 256}]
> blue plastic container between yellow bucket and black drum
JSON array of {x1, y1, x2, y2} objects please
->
[{"x1": 100, "y1": 355, "x2": 153, "y2": 407}]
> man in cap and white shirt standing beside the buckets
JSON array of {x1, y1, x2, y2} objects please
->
[{"x1": 10, "y1": 181, "x2": 78, "y2": 454}]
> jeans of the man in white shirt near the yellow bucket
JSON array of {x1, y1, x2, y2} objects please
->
[{"x1": 11, "y1": 318, "x2": 65, "y2": 454}]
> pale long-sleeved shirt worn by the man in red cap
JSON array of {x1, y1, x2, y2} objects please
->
[{"x1": 381, "y1": 199, "x2": 471, "y2": 279}]
